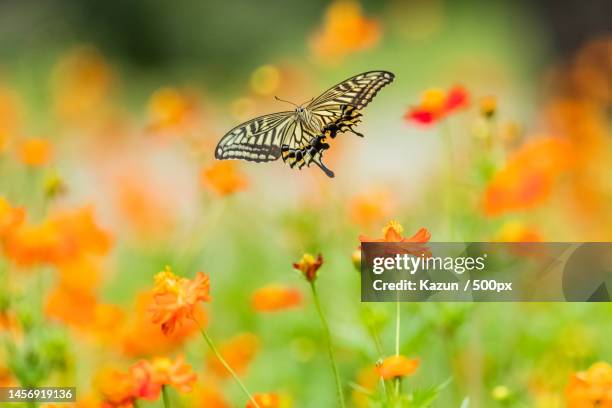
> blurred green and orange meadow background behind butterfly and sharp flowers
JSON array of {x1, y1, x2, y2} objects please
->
[{"x1": 0, "y1": 0, "x2": 612, "y2": 408}]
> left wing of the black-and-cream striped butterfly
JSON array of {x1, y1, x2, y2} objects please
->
[{"x1": 215, "y1": 111, "x2": 296, "y2": 162}]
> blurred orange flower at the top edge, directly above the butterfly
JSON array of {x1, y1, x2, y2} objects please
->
[{"x1": 311, "y1": 0, "x2": 381, "y2": 61}]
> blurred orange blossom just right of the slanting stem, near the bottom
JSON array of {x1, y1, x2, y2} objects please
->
[{"x1": 207, "y1": 333, "x2": 259, "y2": 378}]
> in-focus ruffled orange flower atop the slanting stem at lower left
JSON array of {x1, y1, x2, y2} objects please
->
[{"x1": 151, "y1": 266, "x2": 210, "y2": 335}]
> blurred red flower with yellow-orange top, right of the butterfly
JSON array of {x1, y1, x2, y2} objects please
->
[{"x1": 404, "y1": 86, "x2": 469, "y2": 125}]
